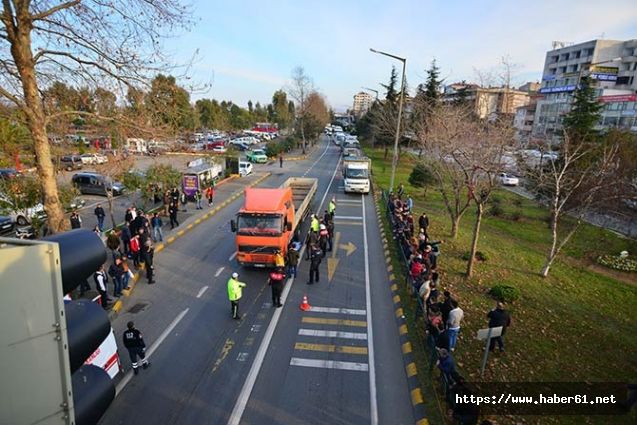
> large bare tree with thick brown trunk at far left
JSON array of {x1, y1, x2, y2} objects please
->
[{"x1": 0, "y1": 0, "x2": 190, "y2": 232}]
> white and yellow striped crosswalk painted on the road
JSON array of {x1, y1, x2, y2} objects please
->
[{"x1": 290, "y1": 306, "x2": 369, "y2": 372}]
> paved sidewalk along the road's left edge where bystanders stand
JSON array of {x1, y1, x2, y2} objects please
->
[{"x1": 104, "y1": 172, "x2": 270, "y2": 320}]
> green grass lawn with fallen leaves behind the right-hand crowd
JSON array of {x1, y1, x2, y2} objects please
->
[{"x1": 366, "y1": 149, "x2": 637, "y2": 423}]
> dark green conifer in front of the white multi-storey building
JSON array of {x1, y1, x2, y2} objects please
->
[{"x1": 562, "y1": 77, "x2": 603, "y2": 143}]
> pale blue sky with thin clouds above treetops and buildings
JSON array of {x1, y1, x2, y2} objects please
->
[{"x1": 165, "y1": 0, "x2": 637, "y2": 111}]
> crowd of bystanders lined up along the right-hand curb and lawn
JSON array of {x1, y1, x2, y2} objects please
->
[{"x1": 387, "y1": 184, "x2": 511, "y2": 424}]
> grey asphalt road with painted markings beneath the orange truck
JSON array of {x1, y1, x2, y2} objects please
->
[{"x1": 100, "y1": 137, "x2": 414, "y2": 424}]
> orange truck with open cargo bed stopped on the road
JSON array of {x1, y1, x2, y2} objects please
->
[{"x1": 230, "y1": 177, "x2": 318, "y2": 267}]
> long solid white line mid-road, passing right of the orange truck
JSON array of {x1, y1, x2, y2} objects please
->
[{"x1": 228, "y1": 143, "x2": 341, "y2": 425}]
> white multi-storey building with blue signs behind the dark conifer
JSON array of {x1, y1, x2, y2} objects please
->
[{"x1": 533, "y1": 39, "x2": 637, "y2": 137}]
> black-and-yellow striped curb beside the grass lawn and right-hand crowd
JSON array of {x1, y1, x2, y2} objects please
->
[{"x1": 373, "y1": 191, "x2": 429, "y2": 425}]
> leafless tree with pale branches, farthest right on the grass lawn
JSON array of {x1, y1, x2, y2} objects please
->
[{"x1": 529, "y1": 134, "x2": 619, "y2": 277}]
